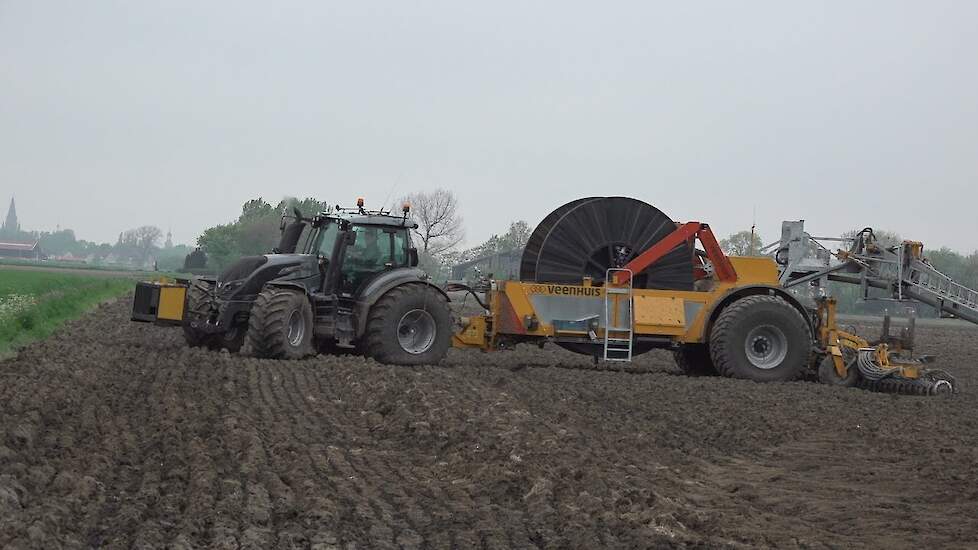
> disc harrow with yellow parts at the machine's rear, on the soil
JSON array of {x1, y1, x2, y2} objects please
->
[{"x1": 857, "y1": 348, "x2": 957, "y2": 395}]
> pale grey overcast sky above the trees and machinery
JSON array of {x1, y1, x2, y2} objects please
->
[{"x1": 0, "y1": 0, "x2": 978, "y2": 252}]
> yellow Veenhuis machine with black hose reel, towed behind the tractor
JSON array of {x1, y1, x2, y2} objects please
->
[{"x1": 453, "y1": 197, "x2": 954, "y2": 394}]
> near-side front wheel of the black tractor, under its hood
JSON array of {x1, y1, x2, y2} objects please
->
[{"x1": 247, "y1": 287, "x2": 313, "y2": 359}]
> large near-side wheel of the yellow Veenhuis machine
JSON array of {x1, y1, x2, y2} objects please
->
[{"x1": 710, "y1": 295, "x2": 813, "y2": 382}]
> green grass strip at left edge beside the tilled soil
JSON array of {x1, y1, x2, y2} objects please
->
[{"x1": 0, "y1": 270, "x2": 134, "y2": 358}]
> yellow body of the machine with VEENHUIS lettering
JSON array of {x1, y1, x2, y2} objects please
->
[{"x1": 453, "y1": 257, "x2": 780, "y2": 349}]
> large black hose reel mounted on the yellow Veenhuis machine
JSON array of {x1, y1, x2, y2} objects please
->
[{"x1": 520, "y1": 197, "x2": 693, "y2": 290}]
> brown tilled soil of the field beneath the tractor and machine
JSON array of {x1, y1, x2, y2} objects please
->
[{"x1": 0, "y1": 301, "x2": 978, "y2": 549}]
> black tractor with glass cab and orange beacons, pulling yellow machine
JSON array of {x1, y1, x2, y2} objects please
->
[{"x1": 182, "y1": 202, "x2": 452, "y2": 365}]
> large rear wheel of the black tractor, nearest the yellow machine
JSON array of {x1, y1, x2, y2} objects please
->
[{"x1": 361, "y1": 283, "x2": 452, "y2": 365}]
